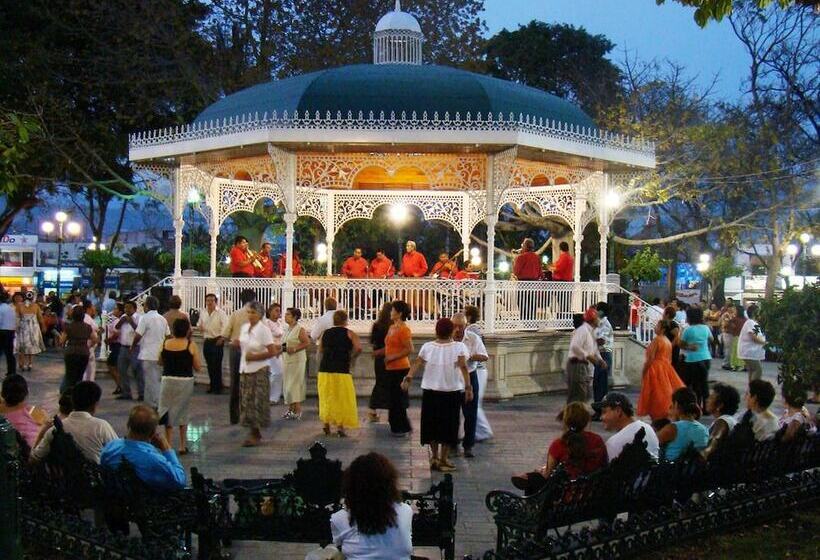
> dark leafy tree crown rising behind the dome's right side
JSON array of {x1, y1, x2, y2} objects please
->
[{"x1": 484, "y1": 20, "x2": 621, "y2": 115}]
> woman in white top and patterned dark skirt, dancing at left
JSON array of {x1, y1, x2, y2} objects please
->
[{"x1": 234, "y1": 302, "x2": 281, "y2": 447}]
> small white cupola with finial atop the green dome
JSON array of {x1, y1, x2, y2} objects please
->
[{"x1": 373, "y1": 0, "x2": 424, "y2": 64}]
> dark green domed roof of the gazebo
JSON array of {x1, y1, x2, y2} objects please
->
[{"x1": 195, "y1": 64, "x2": 595, "y2": 127}]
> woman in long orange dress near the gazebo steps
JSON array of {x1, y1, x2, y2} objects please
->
[{"x1": 638, "y1": 320, "x2": 685, "y2": 421}]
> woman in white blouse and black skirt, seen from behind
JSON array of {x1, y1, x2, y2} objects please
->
[{"x1": 401, "y1": 318, "x2": 473, "y2": 472}]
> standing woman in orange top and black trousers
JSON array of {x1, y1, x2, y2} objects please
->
[{"x1": 384, "y1": 300, "x2": 413, "y2": 437}]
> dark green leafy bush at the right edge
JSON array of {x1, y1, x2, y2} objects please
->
[{"x1": 759, "y1": 284, "x2": 820, "y2": 389}]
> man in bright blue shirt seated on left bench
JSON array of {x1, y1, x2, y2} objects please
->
[{"x1": 100, "y1": 404, "x2": 186, "y2": 490}]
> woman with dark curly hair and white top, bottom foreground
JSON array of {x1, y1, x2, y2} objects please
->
[{"x1": 330, "y1": 453, "x2": 413, "y2": 560}]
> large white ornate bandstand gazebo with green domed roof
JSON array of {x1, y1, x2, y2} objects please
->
[{"x1": 130, "y1": 1, "x2": 655, "y2": 340}]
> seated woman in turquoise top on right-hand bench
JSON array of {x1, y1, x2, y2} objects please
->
[{"x1": 658, "y1": 387, "x2": 709, "y2": 461}]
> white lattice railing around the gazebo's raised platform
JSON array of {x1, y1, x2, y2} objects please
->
[{"x1": 174, "y1": 277, "x2": 601, "y2": 332}]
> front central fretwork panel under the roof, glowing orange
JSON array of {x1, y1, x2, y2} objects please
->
[{"x1": 296, "y1": 153, "x2": 485, "y2": 190}]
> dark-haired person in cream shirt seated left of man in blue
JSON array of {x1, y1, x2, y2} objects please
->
[{"x1": 31, "y1": 381, "x2": 117, "y2": 464}]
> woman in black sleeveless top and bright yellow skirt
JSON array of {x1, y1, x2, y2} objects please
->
[{"x1": 318, "y1": 309, "x2": 362, "y2": 437}]
